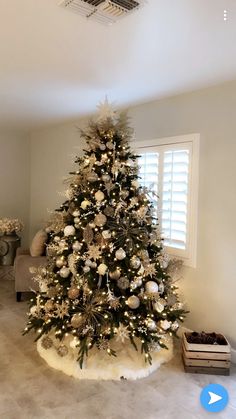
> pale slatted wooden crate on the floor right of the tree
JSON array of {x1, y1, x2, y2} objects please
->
[{"x1": 182, "y1": 333, "x2": 231, "y2": 375}]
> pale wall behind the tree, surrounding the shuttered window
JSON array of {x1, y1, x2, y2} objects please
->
[{"x1": 31, "y1": 82, "x2": 236, "y2": 346}]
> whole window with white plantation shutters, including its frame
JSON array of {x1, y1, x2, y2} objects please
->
[{"x1": 136, "y1": 134, "x2": 199, "y2": 267}]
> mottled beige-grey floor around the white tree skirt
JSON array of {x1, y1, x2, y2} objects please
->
[{"x1": 0, "y1": 280, "x2": 236, "y2": 419}]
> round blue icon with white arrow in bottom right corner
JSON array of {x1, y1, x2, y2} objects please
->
[{"x1": 200, "y1": 384, "x2": 229, "y2": 413}]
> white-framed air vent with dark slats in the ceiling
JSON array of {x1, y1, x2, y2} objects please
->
[{"x1": 60, "y1": 0, "x2": 146, "y2": 24}]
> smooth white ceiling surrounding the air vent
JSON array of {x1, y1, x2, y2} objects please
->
[{"x1": 0, "y1": 0, "x2": 236, "y2": 130}]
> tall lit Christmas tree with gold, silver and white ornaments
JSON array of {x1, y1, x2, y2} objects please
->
[{"x1": 25, "y1": 101, "x2": 185, "y2": 374}]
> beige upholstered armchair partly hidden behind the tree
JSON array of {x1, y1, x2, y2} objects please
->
[{"x1": 14, "y1": 247, "x2": 47, "y2": 302}]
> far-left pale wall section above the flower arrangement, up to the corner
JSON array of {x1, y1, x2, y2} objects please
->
[{"x1": 0, "y1": 132, "x2": 30, "y2": 245}]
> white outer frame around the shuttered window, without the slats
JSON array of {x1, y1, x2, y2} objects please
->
[{"x1": 132, "y1": 134, "x2": 200, "y2": 268}]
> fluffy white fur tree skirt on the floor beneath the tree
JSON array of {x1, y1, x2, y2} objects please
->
[{"x1": 37, "y1": 336, "x2": 173, "y2": 380}]
